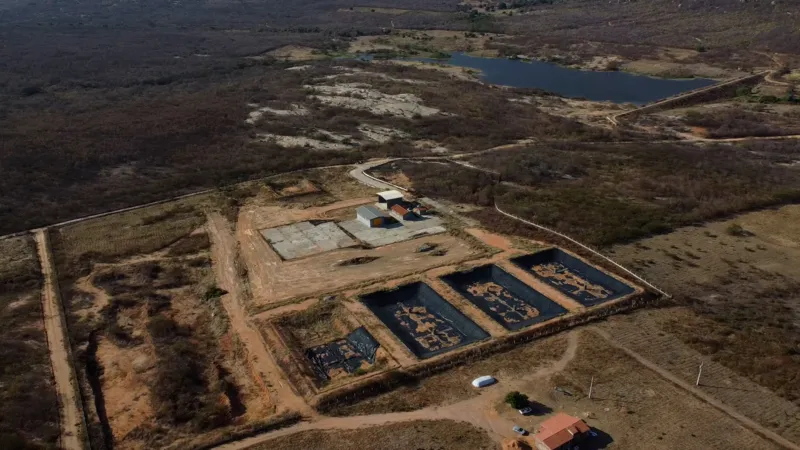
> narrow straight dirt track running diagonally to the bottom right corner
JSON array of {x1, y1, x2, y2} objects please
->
[{"x1": 593, "y1": 328, "x2": 800, "y2": 450}]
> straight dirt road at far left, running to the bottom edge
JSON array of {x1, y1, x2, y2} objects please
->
[{"x1": 34, "y1": 229, "x2": 83, "y2": 450}]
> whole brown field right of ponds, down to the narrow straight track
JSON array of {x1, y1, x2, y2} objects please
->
[{"x1": 609, "y1": 205, "x2": 800, "y2": 442}]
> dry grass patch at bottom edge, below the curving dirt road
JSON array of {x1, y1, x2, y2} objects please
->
[{"x1": 251, "y1": 420, "x2": 497, "y2": 450}]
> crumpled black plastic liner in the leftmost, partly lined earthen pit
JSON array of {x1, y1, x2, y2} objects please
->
[{"x1": 306, "y1": 327, "x2": 380, "y2": 380}]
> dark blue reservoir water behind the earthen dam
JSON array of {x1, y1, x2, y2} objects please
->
[{"x1": 415, "y1": 53, "x2": 716, "y2": 105}]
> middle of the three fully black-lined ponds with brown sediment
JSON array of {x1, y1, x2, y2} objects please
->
[{"x1": 440, "y1": 264, "x2": 567, "y2": 331}]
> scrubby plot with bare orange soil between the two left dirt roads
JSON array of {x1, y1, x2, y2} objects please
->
[{"x1": 52, "y1": 197, "x2": 271, "y2": 449}]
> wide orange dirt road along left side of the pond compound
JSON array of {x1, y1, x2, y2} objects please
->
[{"x1": 208, "y1": 213, "x2": 316, "y2": 417}]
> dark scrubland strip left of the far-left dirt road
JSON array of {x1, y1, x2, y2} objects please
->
[{"x1": 0, "y1": 236, "x2": 59, "y2": 449}]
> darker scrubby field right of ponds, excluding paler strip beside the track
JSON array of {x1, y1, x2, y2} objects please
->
[{"x1": 613, "y1": 205, "x2": 800, "y2": 404}]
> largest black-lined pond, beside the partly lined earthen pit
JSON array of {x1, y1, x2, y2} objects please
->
[{"x1": 361, "y1": 282, "x2": 489, "y2": 359}]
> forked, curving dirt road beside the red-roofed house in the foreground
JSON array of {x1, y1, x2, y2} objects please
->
[{"x1": 211, "y1": 331, "x2": 579, "y2": 450}]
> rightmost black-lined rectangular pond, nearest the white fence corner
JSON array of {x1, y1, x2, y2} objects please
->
[{"x1": 511, "y1": 248, "x2": 634, "y2": 306}]
